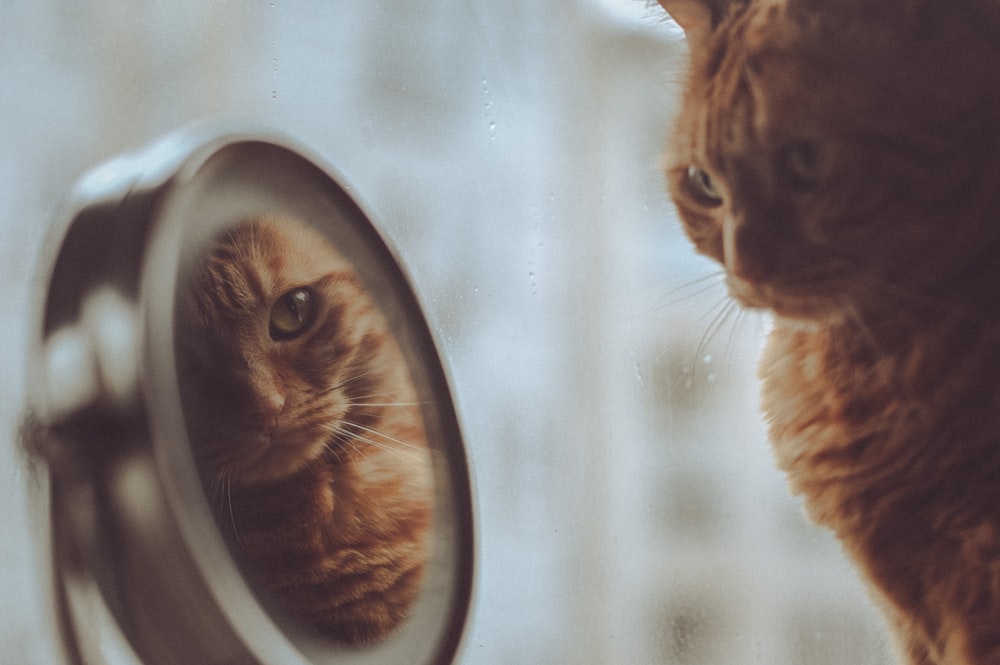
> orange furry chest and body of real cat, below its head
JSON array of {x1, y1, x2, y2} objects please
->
[{"x1": 760, "y1": 314, "x2": 1000, "y2": 663}]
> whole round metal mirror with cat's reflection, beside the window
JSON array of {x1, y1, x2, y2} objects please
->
[{"x1": 28, "y1": 130, "x2": 473, "y2": 665}]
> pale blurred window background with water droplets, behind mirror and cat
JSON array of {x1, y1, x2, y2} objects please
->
[{"x1": 0, "y1": 0, "x2": 888, "y2": 665}]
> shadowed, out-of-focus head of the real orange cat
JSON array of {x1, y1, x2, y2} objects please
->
[{"x1": 660, "y1": 0, "x2": 1000, "y2": 321}]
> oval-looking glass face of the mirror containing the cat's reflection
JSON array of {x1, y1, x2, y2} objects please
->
[{"x1": 148, "y1": 140, "x2": 471, "y2": 663}]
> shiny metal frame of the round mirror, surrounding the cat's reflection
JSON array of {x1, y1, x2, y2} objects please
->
[{"x1": 23, "y1": 125, "x2": 475, "y2": 665}]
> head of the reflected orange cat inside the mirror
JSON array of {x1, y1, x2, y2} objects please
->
[{"x1": 177, "y1": 218, "x2": 386, "y2": 483}]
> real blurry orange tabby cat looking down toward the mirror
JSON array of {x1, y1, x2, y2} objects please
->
[{"x1": 660, "y1": 0, "x2": 1000, "y2": 665}]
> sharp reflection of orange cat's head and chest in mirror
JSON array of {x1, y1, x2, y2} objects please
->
[{"x1": 178, "y1": 217, "x2": 432, "y2": 645}]
